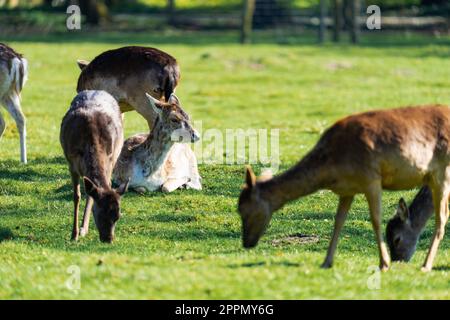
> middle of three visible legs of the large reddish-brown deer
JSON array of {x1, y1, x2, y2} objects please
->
[{"x1": 366, "y1": 183, "x2": 391, "y2": 271}]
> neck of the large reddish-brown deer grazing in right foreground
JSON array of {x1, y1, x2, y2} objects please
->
[{"x1": 258, "y1": 151, "x2": 327, "y2": 211}]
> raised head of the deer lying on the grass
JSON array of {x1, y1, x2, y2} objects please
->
[{"x1": 146, "y1": 93, "x2": 200, "y2": 143}]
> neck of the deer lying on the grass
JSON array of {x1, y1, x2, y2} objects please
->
[{"x1": 141, "y1": 118, "x2": 174, "y2": 175}]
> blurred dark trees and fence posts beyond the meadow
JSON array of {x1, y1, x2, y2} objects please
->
[{"x1": 0, "y1": 0, "x2": 450, "y2": 43}]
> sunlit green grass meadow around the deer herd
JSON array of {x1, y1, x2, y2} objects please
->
[{"x1": 0, "y1": 30, "x2": 450, "y2": 299}]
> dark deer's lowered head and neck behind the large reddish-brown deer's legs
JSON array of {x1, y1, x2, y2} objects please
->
[{"x1": 386, "y1": 186, "x2": 434, "y2": 261}]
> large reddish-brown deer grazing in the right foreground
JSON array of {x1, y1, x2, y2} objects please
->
[{"x1": 238, "y1": 106, "x2": 450, "y2": 271}]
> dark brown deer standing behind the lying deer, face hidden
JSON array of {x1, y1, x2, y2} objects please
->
[{"x1": 77, "y1": 46, "x2": 180, "y2": 127}]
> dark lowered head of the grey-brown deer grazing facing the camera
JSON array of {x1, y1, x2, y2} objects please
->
[{"x1": 83, "y1": 177, "x2": 130, "y2": 243}]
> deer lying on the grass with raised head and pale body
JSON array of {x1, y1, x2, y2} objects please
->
[{"x1": 113, "y1": 94, "x2": 202, "y2": 193}]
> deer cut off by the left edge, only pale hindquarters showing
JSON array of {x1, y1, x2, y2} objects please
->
[{"x1": 0, "y1": 43, "x2": 28, "y2": 164}]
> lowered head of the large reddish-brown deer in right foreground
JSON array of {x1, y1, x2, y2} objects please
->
[{"x1": 238, "y1": 167, "x2": 272, "y2": 248}]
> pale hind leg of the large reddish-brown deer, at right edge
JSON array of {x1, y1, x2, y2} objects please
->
[{"x1": 422, "y1": 188, "x2": 449, "y2": 272}]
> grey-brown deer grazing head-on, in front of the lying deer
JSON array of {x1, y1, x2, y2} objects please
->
[{"x1": 60, "y1": 91, "x2": 128, "y2": 243}]
